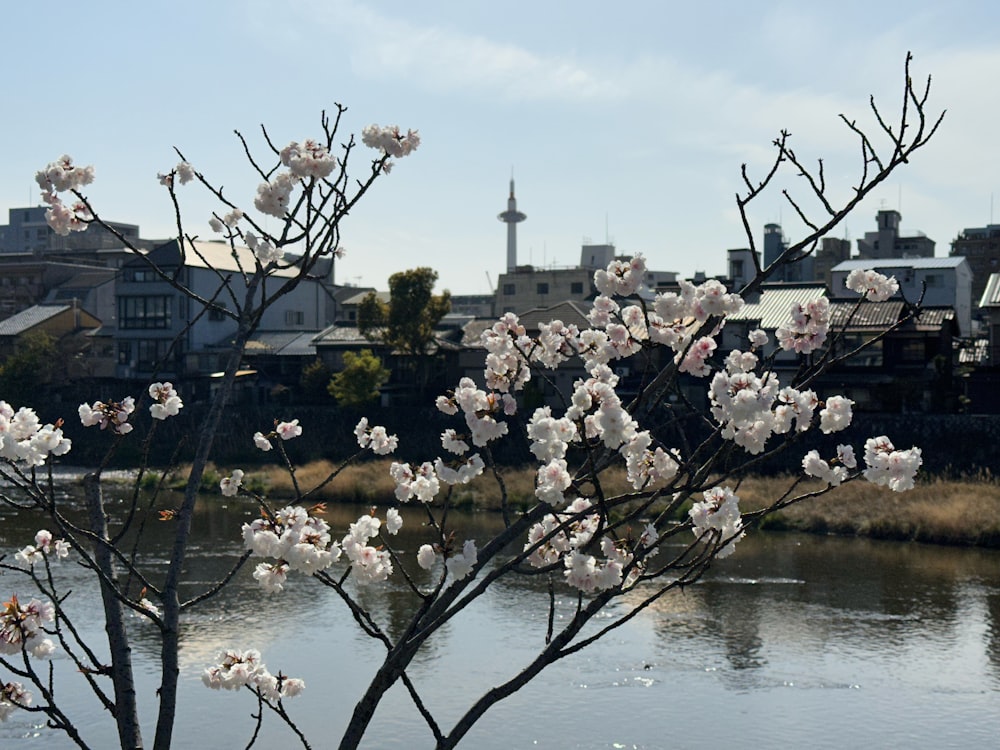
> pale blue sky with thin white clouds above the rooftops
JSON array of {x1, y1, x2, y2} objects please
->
[{"x1": 0, "y1": 0, "x2": 1000, "y2": 294}]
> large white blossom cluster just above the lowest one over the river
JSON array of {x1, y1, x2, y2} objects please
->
[{"x1": 242, "y1": 505, "x2": 341, "y2": 593}]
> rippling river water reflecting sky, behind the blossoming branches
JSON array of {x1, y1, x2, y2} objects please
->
[{"x1": 0, "y1": 498, "x2": 1000, "y2": 750}]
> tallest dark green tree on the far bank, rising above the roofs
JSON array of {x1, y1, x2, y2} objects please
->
[{"x1": 358, "y1": 267, "x2": 451, "y2": 391}]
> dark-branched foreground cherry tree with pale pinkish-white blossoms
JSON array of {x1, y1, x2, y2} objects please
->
[{"x1": 0, "y1": 58, "x2": 940, "y2": 750}]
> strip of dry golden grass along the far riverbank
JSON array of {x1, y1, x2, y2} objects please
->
[{"x1": 248, "y1": 460, "x2": 1000, "y2": 547}]
